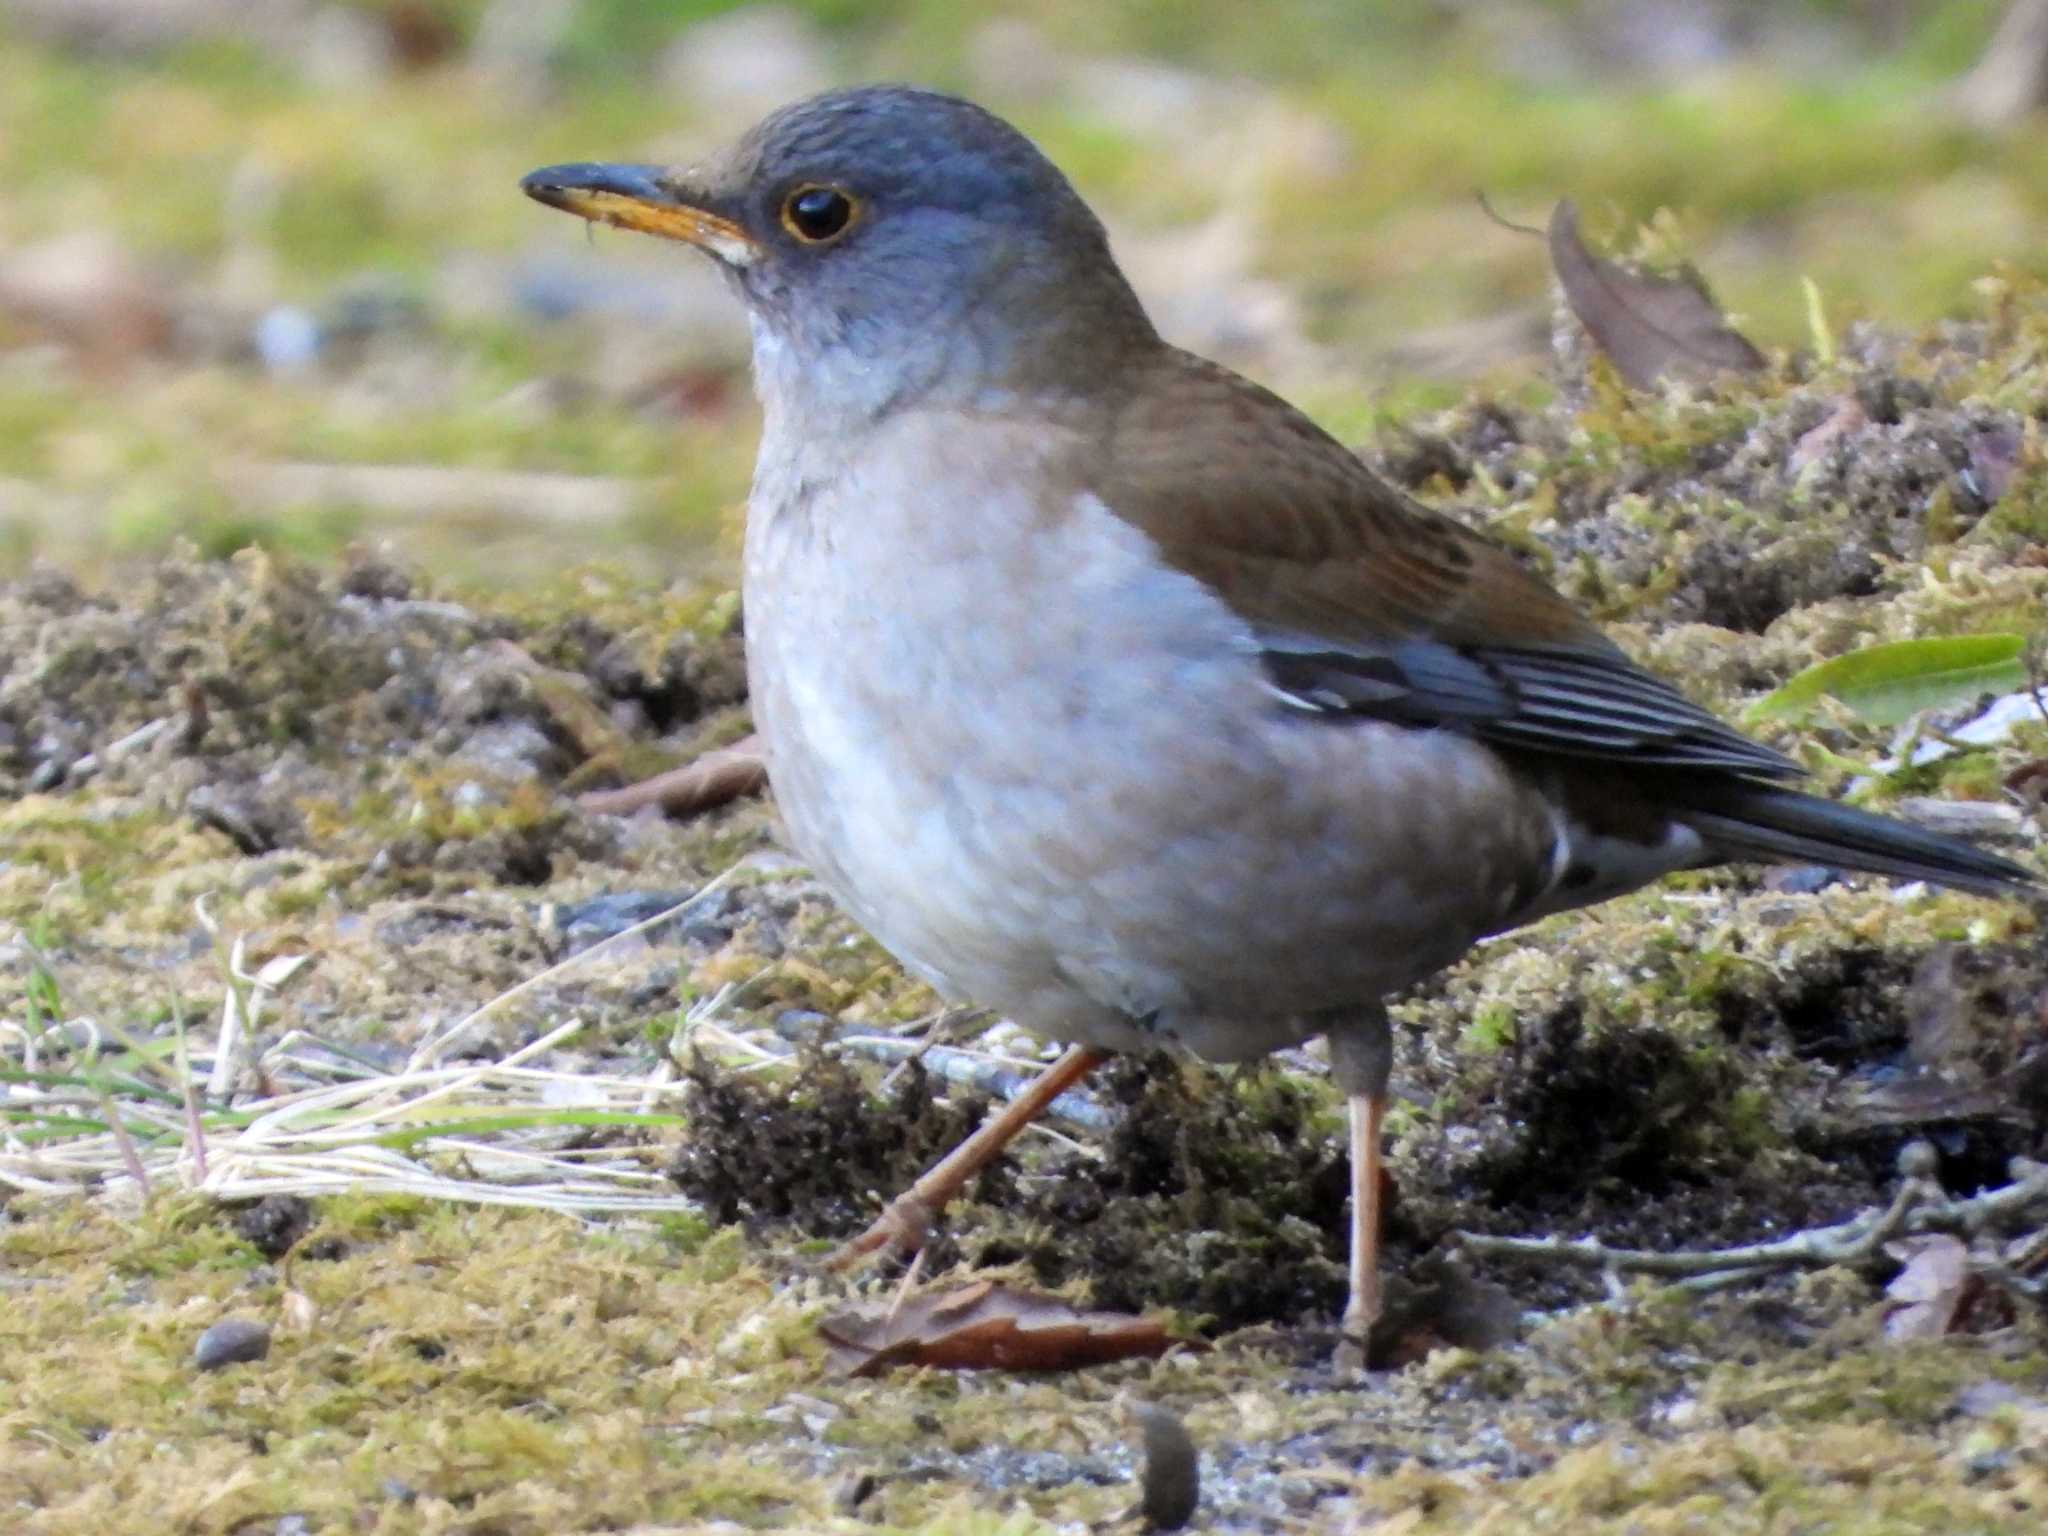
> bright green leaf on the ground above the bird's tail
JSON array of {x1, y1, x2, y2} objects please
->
[{"x1": 1743, "y1": 635, "x2": 2028, "y2": 725}]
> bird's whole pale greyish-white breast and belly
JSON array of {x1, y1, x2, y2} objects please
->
[{"x1": 748, "y1": 409, "x2": 1554, "y2": 1059}]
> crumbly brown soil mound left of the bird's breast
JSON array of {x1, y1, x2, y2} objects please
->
[{"x1": 0, "y1": 551, "x2": 743, "y2": 885}]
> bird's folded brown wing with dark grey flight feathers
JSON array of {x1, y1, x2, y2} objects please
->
[{"x1": 1102, "y1": 352, "x2": 1800, "y2": 778}]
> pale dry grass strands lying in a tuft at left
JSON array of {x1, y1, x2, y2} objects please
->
[{"x1": 0, "y1": 870, "x2": 770, "y2": 1212}]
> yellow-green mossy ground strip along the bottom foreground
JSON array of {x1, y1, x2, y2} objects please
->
[{"x1": 12, "y1": 1200, "x2": 2048, "y2": 1534}]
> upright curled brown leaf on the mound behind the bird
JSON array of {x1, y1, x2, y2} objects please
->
[{"x1": 1550, "y1": 197, "x2": 1765, "y2": 389}]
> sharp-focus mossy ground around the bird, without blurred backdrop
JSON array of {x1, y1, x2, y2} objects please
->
[{"x1": 0, "y1": 319, "x2": 2048, "y2": 1532}]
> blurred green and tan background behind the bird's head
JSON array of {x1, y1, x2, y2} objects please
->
[{"x1": 0, "y1": 0, "x2": 2048, "y2": 586}]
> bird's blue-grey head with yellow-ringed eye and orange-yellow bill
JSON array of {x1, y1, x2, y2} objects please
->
[{"x1": 520, "y1": 86, "x2": 1157, "y2": 416}]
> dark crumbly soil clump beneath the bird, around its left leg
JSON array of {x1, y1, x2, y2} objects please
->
[{"x1": 672, "y1": 1057, "x2": 1350, "y2": 1331}]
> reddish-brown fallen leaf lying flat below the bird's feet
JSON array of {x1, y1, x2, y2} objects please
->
[{"x1": 817, "y1": 1280, "x2": 1200, "y2": 1376}]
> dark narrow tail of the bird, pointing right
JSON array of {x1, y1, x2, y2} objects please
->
[{"x1": 1679, "y1": 782, "x2": 2042, "y2": 895}]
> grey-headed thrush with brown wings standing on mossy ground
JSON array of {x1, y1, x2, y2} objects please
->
[{"x1": 522, "y1": 86, "x2": 2036, "y2": 1370}]
